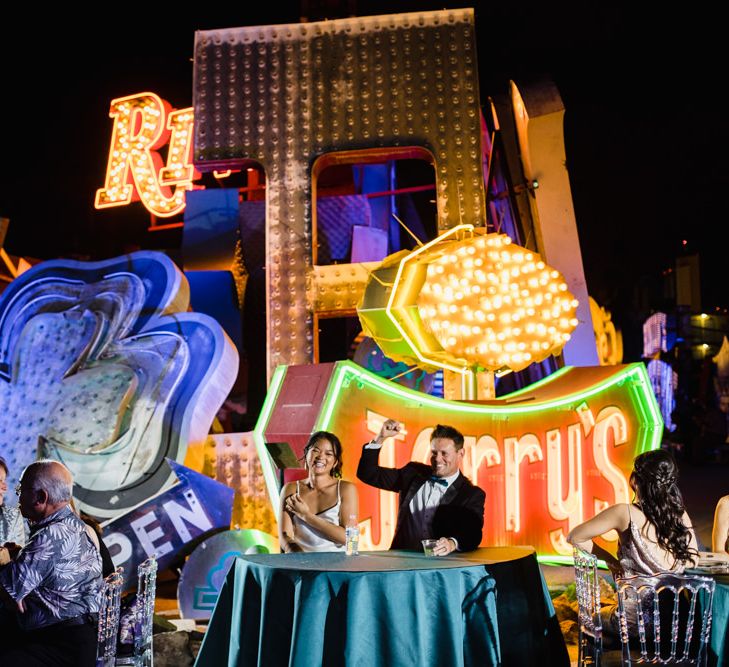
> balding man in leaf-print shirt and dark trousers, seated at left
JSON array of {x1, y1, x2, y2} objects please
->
[{"x1": 0, "y1": 461, "x2": 102, "y2": 667}]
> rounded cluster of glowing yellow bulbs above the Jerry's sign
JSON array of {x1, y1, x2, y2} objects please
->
[{"x1": 417, "y1": 234, "x2": 577, "y2": 371}]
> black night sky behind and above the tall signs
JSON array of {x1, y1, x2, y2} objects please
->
[{"x1": 0, "y1": 0, "x2": 729, "y2": 360}]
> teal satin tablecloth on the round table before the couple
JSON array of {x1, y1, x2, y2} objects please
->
[{"x1": 196, "y1": 547, "x2": 569, "y2": 667}]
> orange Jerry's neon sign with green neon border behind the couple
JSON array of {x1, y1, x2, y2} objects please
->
[{"x1": 255, "y1": 362, "x2": 663, "y2": 555}]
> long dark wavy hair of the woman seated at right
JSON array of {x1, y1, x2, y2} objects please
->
[{"x1": 630, "y1": 449, "x2": 697, "y2": 562}]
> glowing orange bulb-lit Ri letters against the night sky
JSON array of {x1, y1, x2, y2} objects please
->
[{"x1": 94, "y1": 93, "x2": 195, "y2": 218}]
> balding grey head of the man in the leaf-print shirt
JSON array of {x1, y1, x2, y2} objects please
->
[{"x1": 20, "y1": 459, "x2": 73, "y2": 521}]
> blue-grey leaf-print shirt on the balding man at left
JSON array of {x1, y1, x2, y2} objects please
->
[{"x1": 0, "y1": 505, "x2": 102, "y2": 630}]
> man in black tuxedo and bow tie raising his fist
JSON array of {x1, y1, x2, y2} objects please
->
[{"x1": 357, "y1": 419, "x2": 486, "y2": 556}]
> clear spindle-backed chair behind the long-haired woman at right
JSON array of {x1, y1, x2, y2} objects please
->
[{"x1": 615, "y1": 574, "x2": 716, "y2": 665}]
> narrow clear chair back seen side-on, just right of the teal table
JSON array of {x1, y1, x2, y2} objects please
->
[{"x1": 573, "y1": 547, "x2": 602, "y2": 667}]
